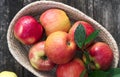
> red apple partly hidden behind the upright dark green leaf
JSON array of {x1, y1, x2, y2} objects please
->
[{"x1": 69, "y1": 21, "x2": 94, "y2": 40}]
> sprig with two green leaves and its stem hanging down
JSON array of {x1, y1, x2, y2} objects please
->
[{"x1": 74, "y1": 24, "x2": 99, "y2": 70}]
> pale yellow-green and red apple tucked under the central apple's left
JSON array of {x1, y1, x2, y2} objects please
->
[{"x1": 29, "y1": 41, "x2": 55, "y2": 71}]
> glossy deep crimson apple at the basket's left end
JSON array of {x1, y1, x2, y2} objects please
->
[{"x1": 14, "y1": 16, "x2": 43, "y2": 45}]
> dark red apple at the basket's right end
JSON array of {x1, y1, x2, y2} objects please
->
[{"x1": 88, "y1": 42, "x2": 113, "y2": 70}]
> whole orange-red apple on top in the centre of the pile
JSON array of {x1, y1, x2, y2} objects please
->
[{"x1": 45, "y1": 31, "x2": 76, "y2": 64}]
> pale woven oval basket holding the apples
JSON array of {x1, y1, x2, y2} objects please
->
[{"x1": 7, "y1": 1, "x2": 119, "y2": 77}]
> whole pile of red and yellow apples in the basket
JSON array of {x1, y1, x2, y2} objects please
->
[{"x1": 14, "y1": 9, "x2": 113, "y2": 77}]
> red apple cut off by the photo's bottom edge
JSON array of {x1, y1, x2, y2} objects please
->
[{"x1": 56, "y1": 58, "x2": 88, "y2": 77}]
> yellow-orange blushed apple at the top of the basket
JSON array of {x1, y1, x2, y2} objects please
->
[{"x1": 39, "y1": 9, "x2": 71, "y2": 35}]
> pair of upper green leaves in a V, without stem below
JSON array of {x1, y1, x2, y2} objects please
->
[{"x1": 74, "y1": 24, "x2": 100, "y2": 49}]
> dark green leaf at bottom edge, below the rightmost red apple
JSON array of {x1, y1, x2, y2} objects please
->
[{"x1": 89, "y1": 70, "x2": 109, "y2": 77}]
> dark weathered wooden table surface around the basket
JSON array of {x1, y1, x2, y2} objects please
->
[{"x1": 0, "y1": 0, "x2": 120, "y2": 77}]
